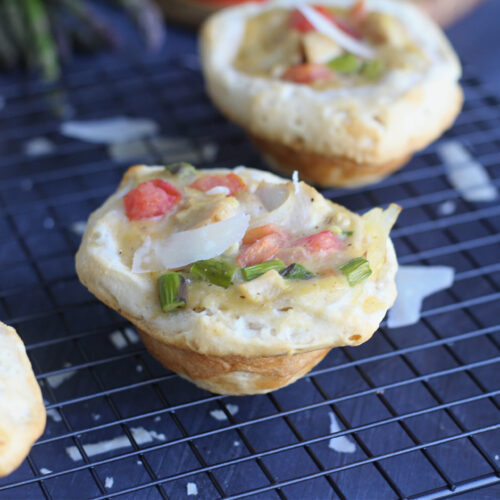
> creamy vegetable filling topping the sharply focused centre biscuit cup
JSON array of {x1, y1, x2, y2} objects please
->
[{"x1": 90, "y1": 168, "x2": 399, "y2": 315}]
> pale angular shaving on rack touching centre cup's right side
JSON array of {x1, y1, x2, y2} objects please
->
[{"x1": 387, "y1": 266, "x2": 455, "y2": 328}]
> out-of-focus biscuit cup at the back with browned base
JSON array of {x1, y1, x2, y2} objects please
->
[{"x1": 201, "y1": 0, "x2": 463, "y2": 187}]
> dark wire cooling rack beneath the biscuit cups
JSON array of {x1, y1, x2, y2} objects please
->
[{"x1": 0, "y1": 44, "x2": 500, "y2": 500}]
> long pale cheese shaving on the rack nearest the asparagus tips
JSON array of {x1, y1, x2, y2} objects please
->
[{"x1": 60, "y1": 116, "x2": 160, "y2": 144}]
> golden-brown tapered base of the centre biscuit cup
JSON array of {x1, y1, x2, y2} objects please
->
[{"x1": 138, "y1": 330, "x2": 330, "y2": 396}]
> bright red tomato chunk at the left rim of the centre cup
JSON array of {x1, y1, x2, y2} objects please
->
[{"x1": 123, "y1": 179, "x2": 182, "y2": 220}]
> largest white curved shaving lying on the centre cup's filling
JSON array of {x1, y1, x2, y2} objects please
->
[{"x1": 132, "y1": 214, "x2": 250, "y2": 273}]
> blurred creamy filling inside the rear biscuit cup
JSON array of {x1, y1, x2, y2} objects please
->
[{"x1": 233, "y1": 7, "x2": 429, "y2": 89}]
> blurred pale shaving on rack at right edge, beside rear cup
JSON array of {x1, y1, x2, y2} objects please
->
[{"x1": 437, "y1": 141, "x2": 498, "y2": 201}]
